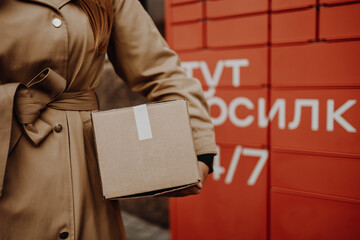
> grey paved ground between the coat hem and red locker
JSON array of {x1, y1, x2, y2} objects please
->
[{"x1": 122, "y1": 211, "x2": 170, "y2": 240}]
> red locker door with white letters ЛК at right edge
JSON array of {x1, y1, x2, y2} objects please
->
[{"x1": 270, "y1": 89, "x2": 360, "y2": 156}]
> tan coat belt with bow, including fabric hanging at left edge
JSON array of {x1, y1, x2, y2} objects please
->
[{"x1": 0, "y1": 68, "x2": 98, "y2": 196}]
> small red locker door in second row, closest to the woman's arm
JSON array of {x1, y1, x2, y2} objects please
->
[{"x1": 172, "y1": 22, "x2": 203, "y2": 51}]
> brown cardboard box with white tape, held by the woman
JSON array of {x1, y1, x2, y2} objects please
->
[{"x1": 92, "y1": 100, "x2": 200, "y2": 199}]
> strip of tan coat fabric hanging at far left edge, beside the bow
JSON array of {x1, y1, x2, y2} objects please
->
[{"x1": 0, "y1": 83, "x2": 20, "y2": 196}]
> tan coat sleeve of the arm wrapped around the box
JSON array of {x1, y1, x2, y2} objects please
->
[{"x1": 108, "y1": 0, "x2": 216, "y2": 155}]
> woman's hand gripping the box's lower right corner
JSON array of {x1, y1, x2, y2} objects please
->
[{"x1": 159, "y1": 161, "x2": 209, "y2": 197}]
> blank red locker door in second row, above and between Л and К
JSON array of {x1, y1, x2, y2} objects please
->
[{"x1": 271, "y1": 8, "x2": 316, "y2": 43}]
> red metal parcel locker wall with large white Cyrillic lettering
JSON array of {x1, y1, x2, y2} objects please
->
[{"x1": 170, "y1": 0, "x2": 360, "y2": 240}]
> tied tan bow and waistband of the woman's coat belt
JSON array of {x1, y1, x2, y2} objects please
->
[{"x1": 12, "y1": 68, "x2": 98, "y2": 146}]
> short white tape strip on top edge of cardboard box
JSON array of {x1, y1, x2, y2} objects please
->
[{"x1": 133, "y1": 104, "x2": 152, "y2": 141}]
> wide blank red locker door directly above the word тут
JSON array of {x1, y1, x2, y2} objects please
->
[{"x1": 207, "y1": 14, "x2": 268, "y2": 47}]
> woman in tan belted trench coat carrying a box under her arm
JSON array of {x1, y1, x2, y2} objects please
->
[{"x1": 0, "y1": 0, "x2": 215, "y2": 240}]
